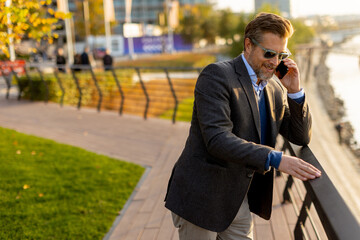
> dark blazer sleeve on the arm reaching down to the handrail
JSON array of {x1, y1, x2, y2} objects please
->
[{"x1": 195, "y1": 63, "x2": 273, "y2": 174}]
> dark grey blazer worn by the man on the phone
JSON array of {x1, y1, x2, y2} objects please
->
[{"x1": 165, "y1": 56, "x2": 311, "y2": 232}]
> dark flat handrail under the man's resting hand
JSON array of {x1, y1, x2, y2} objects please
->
[{"x1": 284, "y1": 139, "x2": 360, "y2": 240}]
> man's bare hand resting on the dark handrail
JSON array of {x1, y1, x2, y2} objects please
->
[{"x1": 279, "y1": 155, "x2": 321, "y2": 181}]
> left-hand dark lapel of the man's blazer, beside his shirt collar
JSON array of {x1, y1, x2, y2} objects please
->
[{"x1": 234, "y1": 55, "x2": 261, "y2": 140}]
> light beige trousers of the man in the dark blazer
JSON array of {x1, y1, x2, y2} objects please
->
[{"x1": 172, "y1": 196, "x2": 253, "y2": 240}]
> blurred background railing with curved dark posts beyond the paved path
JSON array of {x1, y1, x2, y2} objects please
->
[{"x1": 0, "y1": 64, "x2": 201, "y2": 123}]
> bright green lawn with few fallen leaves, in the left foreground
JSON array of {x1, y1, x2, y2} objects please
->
[{"x1": 0, "y1": 128, "x2": 144, "y2": 239}]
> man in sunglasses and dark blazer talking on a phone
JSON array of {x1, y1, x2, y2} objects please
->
[{"x1": 165, "y1": 13, "x2": 321, "y2": 240}]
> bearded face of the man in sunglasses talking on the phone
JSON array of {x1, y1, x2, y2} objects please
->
[{"x1": 244, "y1": 33, "x2": 287, "y2": 81}]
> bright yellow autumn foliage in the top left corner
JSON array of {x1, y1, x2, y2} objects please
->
[{"x1": 0, "y1": 0, "x2": 70, "y2": 57}]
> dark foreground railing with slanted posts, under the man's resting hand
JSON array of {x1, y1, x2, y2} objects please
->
[{"x1": 281, "y1": 140, "x2": 360, "y2": 240}]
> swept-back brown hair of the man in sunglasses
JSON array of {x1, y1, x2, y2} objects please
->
[{"x1": 244, "y1": 12, "x2": 294, "y2": 48}]
